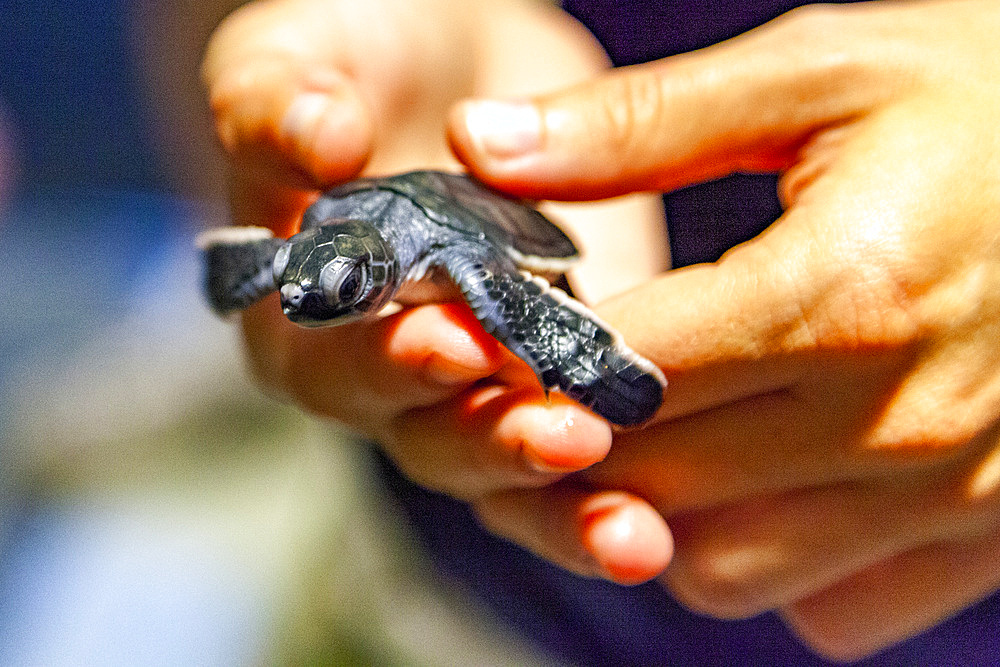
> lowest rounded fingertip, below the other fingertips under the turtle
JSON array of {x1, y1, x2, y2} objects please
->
[{"x1": 581, "y1": 493, "x2": 674, "y2": 586}]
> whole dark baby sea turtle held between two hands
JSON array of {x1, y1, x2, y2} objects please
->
[{"x1": 200, "y1": 171, "x2": 666, "y2": 425}]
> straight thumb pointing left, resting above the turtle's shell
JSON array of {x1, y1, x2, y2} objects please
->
[{"x1": 449, "y1": 5, "x2": 886, "y2": 199}]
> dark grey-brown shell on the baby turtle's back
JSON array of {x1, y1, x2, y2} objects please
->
[{"x1": 302, "y1": 171, "x2": 579, "y2": 266}]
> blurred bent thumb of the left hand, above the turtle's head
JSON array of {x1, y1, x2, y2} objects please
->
[{"x1": 202, "y1": 2, "x2": 373, "y2": 234}]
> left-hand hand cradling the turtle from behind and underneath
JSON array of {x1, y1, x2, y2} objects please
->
[{"x1": 202, "y1": 0, "x2": 671, "y2": 583}]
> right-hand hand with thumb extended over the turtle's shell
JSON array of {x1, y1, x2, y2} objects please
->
[{"x1": 450, "y1": 0, "x2": 1000, "y2": 659}]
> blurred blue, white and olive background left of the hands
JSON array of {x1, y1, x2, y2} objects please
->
[{"x1": 0, "y1": 0, "x2": 539, "y2": 665}]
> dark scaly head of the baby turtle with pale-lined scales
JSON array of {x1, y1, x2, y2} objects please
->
[{"x1": 272, "y1": 220, "x2": 399, "y2": 326}]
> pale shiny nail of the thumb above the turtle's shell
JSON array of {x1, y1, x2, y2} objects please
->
[{"x1": 461, "y1": 100, "x2": 542, "y2": 159}]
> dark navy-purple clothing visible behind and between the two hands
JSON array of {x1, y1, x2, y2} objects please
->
[{"x1": 384, "y1": 0, "x2": 1000, "y2": 665}]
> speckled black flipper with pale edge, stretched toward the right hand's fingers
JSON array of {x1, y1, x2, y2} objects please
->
[{"x1": 444, "y1": 248, "x2": 666, "y2": 426}]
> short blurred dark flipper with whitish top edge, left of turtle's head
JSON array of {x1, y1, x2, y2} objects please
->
[{"x1": 198, "y1": 227, "x2": 284, "y2": 315}]
